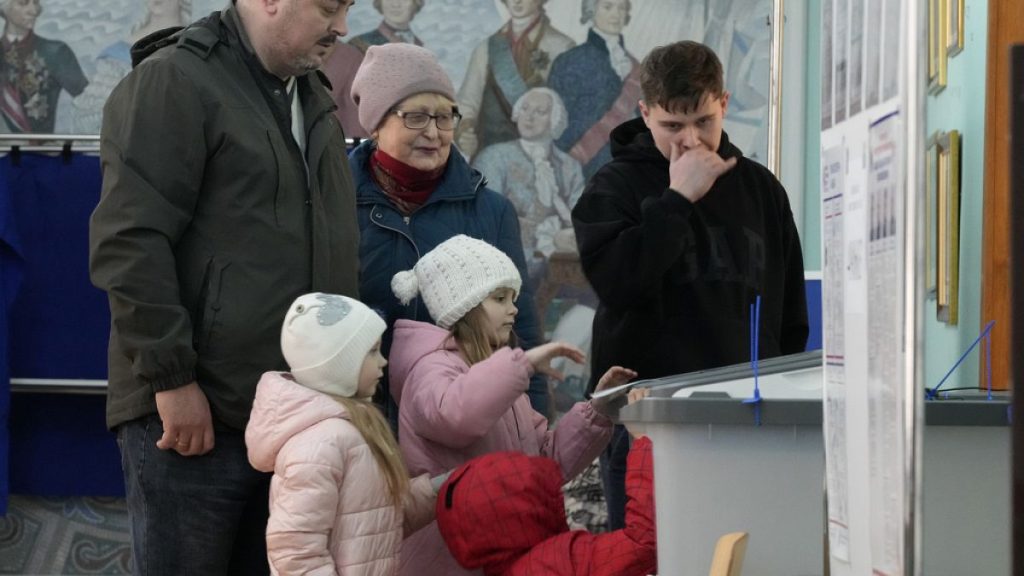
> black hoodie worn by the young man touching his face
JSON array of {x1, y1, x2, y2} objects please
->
[{"x1": 572, "y1": 118, "x2": 808, "y2": 389}]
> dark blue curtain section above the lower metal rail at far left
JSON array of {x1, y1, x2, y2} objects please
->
[{"x1": 6, "y1": 154, "x2": 110, "y2": 379}]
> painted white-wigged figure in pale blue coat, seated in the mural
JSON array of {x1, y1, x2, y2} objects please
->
[{"x1": 473, "y1": 88, "x2": 584, "y2": 282}]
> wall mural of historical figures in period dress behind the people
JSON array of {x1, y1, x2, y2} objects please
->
[{"x1": 9, "y1": 0, "x2": 771, "y2": 412}]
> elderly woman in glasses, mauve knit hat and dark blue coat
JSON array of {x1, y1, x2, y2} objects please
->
[{"x1": 349, "y1": 43, "x2": 548, "y2": 422}]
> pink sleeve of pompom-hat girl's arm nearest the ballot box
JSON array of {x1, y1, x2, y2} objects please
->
[{"x1": 534, "y1": 402, "x2": 612, "y2": 481}]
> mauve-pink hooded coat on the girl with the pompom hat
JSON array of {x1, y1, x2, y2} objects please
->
[{"x1": 388, "y1": 320, "x2": 611, "y2": 576}]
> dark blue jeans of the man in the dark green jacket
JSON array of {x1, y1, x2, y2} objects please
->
[{"x1": 117, "y1": 415, "x2": 270, "y2": 576}]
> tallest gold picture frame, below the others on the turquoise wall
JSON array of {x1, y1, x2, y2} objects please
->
[{"x1": 936, "y1": 130, "x2": 961, "y2": 325}]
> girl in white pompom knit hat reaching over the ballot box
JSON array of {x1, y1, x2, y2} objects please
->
[{"x1": 389, "y1": 235, "x2": 636, "y2": 575}]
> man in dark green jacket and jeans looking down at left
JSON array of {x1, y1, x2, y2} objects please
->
[{"x1": 90, "y1": 0, "x2": 359, "y2": 574}]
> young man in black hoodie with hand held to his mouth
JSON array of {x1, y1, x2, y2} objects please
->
[{"x1": 572, "y1": 41, "x2": 808, "y2": 530}]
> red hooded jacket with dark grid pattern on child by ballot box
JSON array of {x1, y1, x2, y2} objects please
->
[{"x1": 437, "y1": 437, "x2": 657, "y2": 576}]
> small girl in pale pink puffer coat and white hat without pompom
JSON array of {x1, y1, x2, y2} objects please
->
[{"x1": 246, "y1": 293, "x2": 443, "y2": 576}]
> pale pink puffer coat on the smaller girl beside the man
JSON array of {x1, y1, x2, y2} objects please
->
[{"x1": 246, "y1": 372, "x2": 434, "y2": 576}]
